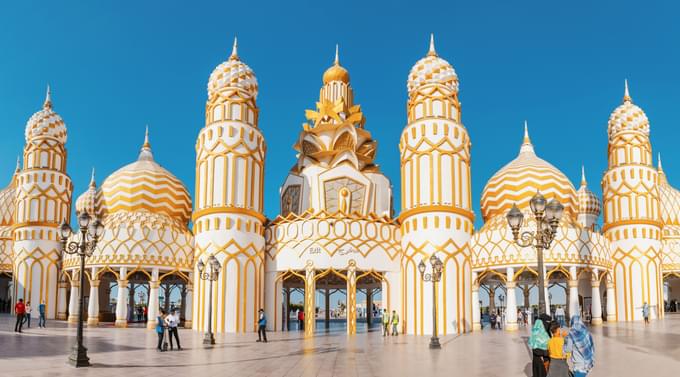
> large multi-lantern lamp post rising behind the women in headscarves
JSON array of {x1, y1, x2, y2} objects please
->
[{"x1": 506, "y1": 192, "x2": 564, "y2": 314}]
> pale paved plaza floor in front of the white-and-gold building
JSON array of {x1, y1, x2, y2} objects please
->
[{"x1": 0, "y1": 315, "x2": 680, "y2": 377}]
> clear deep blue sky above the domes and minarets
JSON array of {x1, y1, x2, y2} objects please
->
[{"x1": 0, "y1": 1, "x2": 680, "y2": 226}]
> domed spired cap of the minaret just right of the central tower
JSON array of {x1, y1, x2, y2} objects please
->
[{"x1": 406, "y1": 35, "x2": 458, "y2": 93}]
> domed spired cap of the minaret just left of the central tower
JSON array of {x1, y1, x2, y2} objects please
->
[{"x1": 208, "y1": 38, "x2": 257, "y2": 98}]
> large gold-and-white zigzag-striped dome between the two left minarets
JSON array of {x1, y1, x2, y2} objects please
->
[{"x1": 97, "y1": 128, "x2": 191, "y2": 225}]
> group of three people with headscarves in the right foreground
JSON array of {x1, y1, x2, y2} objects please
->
[{"x1": 528, "y1": 314, "x2": 595, "y2": 377}]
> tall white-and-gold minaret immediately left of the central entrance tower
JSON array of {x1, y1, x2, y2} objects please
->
[{"x1": 193, "y1": 40, "x2": 266, "y2": 332}]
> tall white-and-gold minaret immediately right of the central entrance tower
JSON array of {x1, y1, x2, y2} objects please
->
[{"x1": 399, "y1": 38, "x2": 474, "y2": 335}]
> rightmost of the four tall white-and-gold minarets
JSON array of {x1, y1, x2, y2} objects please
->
[{"x1": 602, "y1": 81, "x2": 663, "y2": 321}]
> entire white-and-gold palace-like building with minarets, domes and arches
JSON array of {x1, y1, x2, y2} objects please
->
[{"x1": 0, "y1": 40, "x2": 680, "y2": 335}]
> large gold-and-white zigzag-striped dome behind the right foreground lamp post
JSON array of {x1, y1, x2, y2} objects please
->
[{"x1": 482, "y1": 122, "x2": 576, "y2": 221}]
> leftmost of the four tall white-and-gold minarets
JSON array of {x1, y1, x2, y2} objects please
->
[{"x1": 13, "y1": 87, "x2": 73, "y2": 319}]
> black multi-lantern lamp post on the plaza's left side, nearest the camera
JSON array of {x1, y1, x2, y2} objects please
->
[{"x1": 59, "y1": 212, "x2": 104, "y2": 368}]
